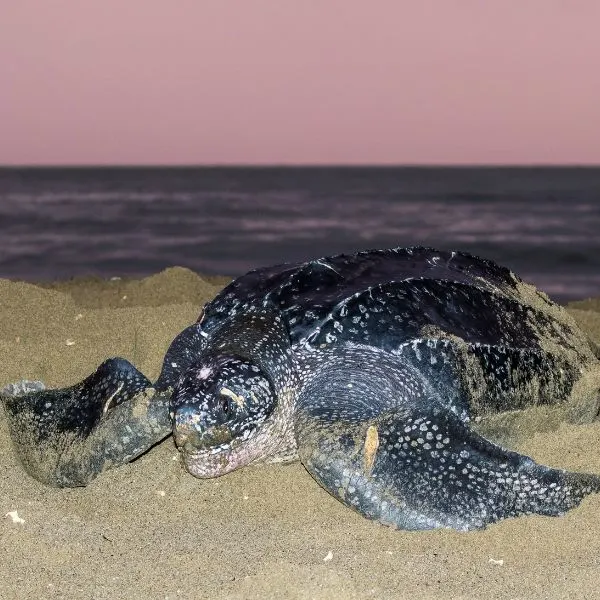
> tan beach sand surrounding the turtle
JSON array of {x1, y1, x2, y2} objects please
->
[{"x1": 0, "y1": 268, "x2": 600, "y2": 599}]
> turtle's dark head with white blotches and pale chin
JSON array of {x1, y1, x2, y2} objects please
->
[{"x1": 170, "y1": 355, "x2": 277, "y2": 477}]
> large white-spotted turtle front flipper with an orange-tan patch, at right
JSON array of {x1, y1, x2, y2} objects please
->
[{"x1": 296, "y1": 354, "x2": 600, "y2": 531}]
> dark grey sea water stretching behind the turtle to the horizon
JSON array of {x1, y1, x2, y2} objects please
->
[{"x1": 0, "y1": 167, "x2": 600, "y2": 301}]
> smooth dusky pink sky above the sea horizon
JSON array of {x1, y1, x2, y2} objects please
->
[{"x1": 0, "y1": 0, "x2": 600, "y2": 164}]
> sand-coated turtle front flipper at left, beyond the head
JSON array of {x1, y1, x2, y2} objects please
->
[{"x1": 0, "y1": 358, "x2": 171, "y2": 487}]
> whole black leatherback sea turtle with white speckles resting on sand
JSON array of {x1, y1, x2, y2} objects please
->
[{"x1": 3, "y1": 247, "x2": 600, "y2": 530}]
